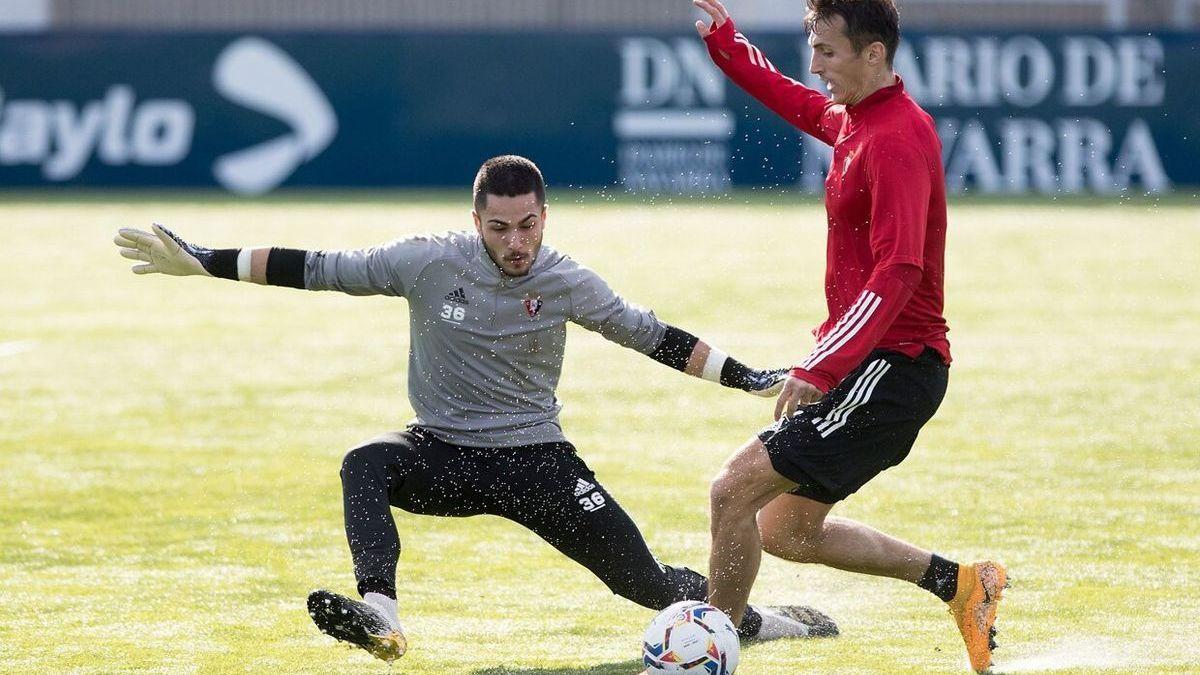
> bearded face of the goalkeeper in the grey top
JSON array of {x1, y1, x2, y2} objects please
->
[{"x1": 472, "y1": 192, "x2": 546, "y2": 276}]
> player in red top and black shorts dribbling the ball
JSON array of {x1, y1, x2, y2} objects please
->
[{"x1": 694, "y1": 0, "x2": 1007, "y2": 671}]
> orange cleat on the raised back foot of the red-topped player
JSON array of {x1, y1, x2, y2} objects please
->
[{"x1": 949, "y1": 561, "x2": 1008, "y2": 673}]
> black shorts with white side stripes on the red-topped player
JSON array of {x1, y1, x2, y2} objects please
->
[{"x1": 758, "y1": 348, "x2": 949, "y2": 504}]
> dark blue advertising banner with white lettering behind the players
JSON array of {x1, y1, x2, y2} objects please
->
[{"x1": 0, "y1": 32, "x2": 1200, "y2": 195}]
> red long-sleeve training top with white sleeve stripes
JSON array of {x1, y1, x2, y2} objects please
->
[{"x1": 706, "y1": 19, "x2": 950, "y2": 392}]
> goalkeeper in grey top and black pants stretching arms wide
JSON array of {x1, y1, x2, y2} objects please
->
[{"x1": 115, "y1": 155, "x2": 836, "y2": 662}]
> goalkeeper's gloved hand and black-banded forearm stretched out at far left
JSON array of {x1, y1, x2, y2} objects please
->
[{"x1": 113, "y1": 223, "x2": 308, "y2": 288}]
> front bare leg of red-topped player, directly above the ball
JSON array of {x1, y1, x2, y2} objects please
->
[{"x1": 708, "y1": 438, "x2": 796, "y2": 625}]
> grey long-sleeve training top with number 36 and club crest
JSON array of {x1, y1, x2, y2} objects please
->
[{"x1": 305, "y1": 232, "x2": 666, "y2": 447}]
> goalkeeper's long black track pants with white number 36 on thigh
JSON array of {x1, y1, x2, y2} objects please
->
[{"x1": 342, "y1": 428, "x2": 706, "y2": 609}]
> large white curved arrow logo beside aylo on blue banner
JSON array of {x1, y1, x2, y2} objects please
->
[{"x1": 212, "y1": 37, "x2": 337, "y2": 195}]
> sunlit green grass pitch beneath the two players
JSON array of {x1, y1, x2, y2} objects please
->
[{"x1": 0, "y1": 192, "x2": 1200, "y2": 675}]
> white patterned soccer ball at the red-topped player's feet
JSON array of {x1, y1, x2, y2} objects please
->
[{"x1": 642, "y1": 601, "x2": 740, "y2": 675}]
